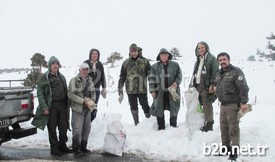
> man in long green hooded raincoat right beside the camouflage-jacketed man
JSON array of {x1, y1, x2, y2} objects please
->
[{"x1": 149, "y1": 48, "x2": 182, "y2": 130}]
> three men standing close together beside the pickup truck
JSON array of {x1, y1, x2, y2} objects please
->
[{"x1": 32, "y1": 49, "x2": 107, "y2": 156}]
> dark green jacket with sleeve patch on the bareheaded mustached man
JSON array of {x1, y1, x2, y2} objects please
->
[{"x1": 216, "y1": 65, "x2": 249, "y2": 105}]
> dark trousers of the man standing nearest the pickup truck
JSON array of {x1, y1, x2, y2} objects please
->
[{"x1": 47, "y1": 101, "x2": 68, "y2": 151}]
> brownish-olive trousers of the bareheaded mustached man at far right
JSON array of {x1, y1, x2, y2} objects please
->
[{"x1": 220, "y1": 104, "x2": 240, "y2": 146}]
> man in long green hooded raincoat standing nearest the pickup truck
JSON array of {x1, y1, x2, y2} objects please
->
[{"x1": 32, "y1": 56, "x2": 72, "y2": 156}]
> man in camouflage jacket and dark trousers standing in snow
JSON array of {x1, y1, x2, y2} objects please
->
[{"x1": 118, "y1": 43, "x2": 151, "y2": 125}]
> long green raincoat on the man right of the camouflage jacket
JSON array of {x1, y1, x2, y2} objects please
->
[{"x1": 149, "y1": 61, "x2": 182, "y2": 117}]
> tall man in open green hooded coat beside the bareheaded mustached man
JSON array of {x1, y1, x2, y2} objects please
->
[{"x1": 190, "y1": 42, "x2": 219, "y2": 132}]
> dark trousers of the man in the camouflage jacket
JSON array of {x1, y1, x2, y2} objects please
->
[{"x1": 128, "y1": 94, "x2": 150, "y2": 113}]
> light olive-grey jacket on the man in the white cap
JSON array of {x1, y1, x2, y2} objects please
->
[{"x1": 68, "y1": 74, "x2": 96, "y2": 113}]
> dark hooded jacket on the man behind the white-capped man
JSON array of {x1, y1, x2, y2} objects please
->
[{"x1": 84, "y1": 49, "x2": 106, "y2": 91}]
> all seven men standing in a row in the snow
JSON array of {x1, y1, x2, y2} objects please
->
[{"x1": 32, "y1": 42, "x2": 249, "y2": 161}]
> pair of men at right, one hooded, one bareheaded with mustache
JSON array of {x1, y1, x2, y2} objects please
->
[{"x1": 192, "y1": 42, "x2": 249, "y2": 160}]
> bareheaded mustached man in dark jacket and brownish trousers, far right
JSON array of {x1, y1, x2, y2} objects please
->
[{"x1": 216, "y1": 52, "x2": 249, "y2": 160}]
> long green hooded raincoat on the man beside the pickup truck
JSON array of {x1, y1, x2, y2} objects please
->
[{"x1": 31, "y1": 56, "x2": 70, "y2": 130}]
